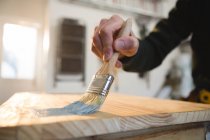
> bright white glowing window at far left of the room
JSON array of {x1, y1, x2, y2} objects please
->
[{"x1": 1, "y1": 24, "x2": 37, "y2": 79}]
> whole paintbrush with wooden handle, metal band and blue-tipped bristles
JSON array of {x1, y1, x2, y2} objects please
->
[{"x1": 64, "y1": 19, "x2": 132, "y2": 114}]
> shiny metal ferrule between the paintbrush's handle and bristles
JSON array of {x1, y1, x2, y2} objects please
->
[{"x1": 87, "y1": 74, "x2": 114, "y2": 96}]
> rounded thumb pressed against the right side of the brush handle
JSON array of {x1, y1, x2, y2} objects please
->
[{"x1": 114, "y1": 36, "x2": 139, "y2": 57}]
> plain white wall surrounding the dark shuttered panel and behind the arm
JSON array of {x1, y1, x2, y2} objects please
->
[{"x1": 47, "y1": 0, "x2": 179, "y2": 96}]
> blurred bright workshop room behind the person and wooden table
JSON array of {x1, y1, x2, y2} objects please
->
[{"x1": 0, "y1": 0, "x2": 193, "y2": 104}]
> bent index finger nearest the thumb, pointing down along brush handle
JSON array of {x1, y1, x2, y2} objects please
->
[{"x1": 99, "y1": 15, "x2": 123, "y2": 61}]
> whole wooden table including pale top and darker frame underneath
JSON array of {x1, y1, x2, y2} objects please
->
[{"x1": 0, "y1": 93, "x2": 210, "y2": 140}]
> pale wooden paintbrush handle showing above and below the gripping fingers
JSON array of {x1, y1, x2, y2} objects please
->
[{"x1": 108, "y1": 18, "x2": 132, "y2": 73}]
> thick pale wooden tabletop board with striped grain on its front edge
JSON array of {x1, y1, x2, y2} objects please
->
[{"x1": 0, "y1": 93, "x2": 210, "y2": 140}]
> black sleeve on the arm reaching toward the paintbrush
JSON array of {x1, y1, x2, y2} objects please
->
[{"x1": 121, "y1": 0, "x2": 193, "y2": 73}]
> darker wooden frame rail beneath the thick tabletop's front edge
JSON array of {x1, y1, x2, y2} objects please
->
[{"x1": 88, "y1": 123, "x2": 205, "y2": 140}]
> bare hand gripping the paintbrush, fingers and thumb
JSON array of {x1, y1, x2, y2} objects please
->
[{"x1": 92, "y1": 15, "x2": 139, "y2": 67}]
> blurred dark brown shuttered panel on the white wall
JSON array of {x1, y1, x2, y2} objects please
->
[{"x1": 56, "y1": 19, "x2": 85, "y2": 81}]
